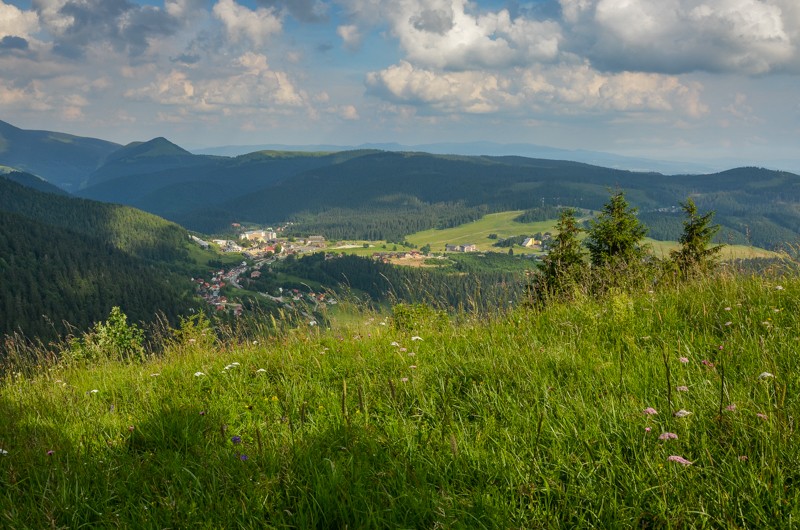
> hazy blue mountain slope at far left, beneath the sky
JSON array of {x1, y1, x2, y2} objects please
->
[{"x1": 0, "y1": 121, "x2": 120, "y2": 191}]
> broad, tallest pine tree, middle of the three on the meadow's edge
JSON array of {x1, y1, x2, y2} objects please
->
[{"x1": 584, "y1": 191, "x2": 647, "y2": 267}]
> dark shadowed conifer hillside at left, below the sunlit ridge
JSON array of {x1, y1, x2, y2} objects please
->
[{"x1": 0, "y1": 210, "x2": 191, "y2": 340}]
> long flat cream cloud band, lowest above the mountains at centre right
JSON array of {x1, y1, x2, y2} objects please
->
[{"x1": 366, "y1": 61, "x2": 708, "y2": 118}]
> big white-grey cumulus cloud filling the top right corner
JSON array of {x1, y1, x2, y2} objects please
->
[{"x1": 560, "y1": 0, "x2": 798, "y2": 74}]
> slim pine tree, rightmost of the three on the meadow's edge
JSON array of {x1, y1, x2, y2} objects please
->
[{"x1": 670, "y1": 198, "x2": 724, "y2": 276}]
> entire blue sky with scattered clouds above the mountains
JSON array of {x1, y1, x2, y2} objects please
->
[{"x1": 0, "y1": 0, "x2": 800, "y2": 168}]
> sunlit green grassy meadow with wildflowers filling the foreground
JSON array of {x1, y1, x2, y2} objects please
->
[{"x1": 0, "y1": 270, "x2": 800, "y2": 528}]
